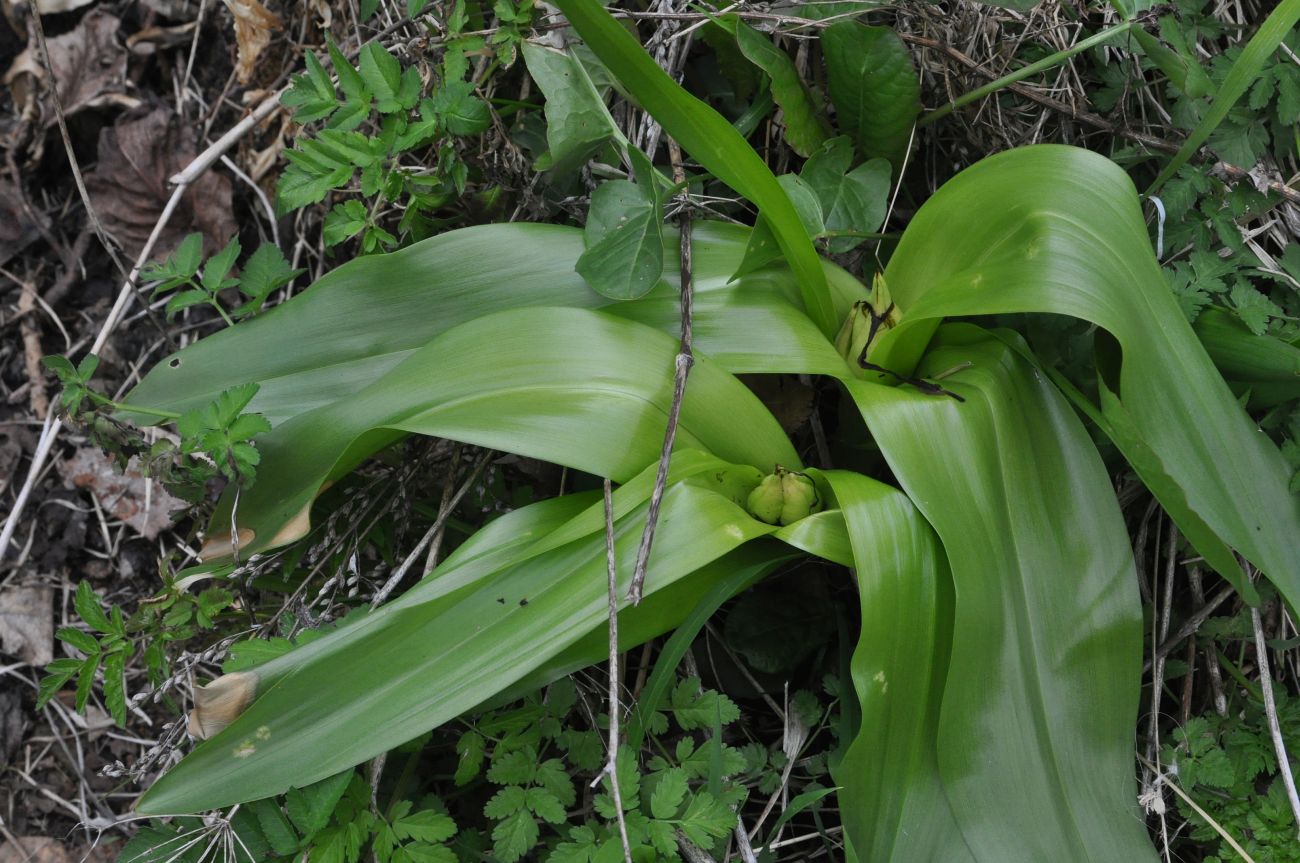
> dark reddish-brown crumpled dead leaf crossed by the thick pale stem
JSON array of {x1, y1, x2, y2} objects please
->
[{"x1": 86, "y1": 107, "x2": 235, "y2": 259}]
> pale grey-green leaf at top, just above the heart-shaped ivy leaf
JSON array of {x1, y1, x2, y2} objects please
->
[{"x1": 524, "y1": 42, "x2": 623, "y2": 177}]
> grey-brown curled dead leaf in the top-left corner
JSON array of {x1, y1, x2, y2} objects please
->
[{"x1": 4, "y1": 9, "x2": 139, "y2": 127}]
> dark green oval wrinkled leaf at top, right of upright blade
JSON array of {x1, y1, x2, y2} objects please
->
[{"x1": 822, "y1": 21, "x2": 920, "y2": 175}]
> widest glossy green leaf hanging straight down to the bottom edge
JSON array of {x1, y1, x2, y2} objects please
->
[{"x1": 836, "y1": 325, "x2": 1156, "y2": 862}]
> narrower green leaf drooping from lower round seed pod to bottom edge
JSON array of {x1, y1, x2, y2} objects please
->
[{"x1": 824, "y1": 470, "x2": 975, "y2": 863}]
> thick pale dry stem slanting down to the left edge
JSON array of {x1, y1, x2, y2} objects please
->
[{"x1": 0, "y1": 90, "x2": 280, "y2": 560}]
